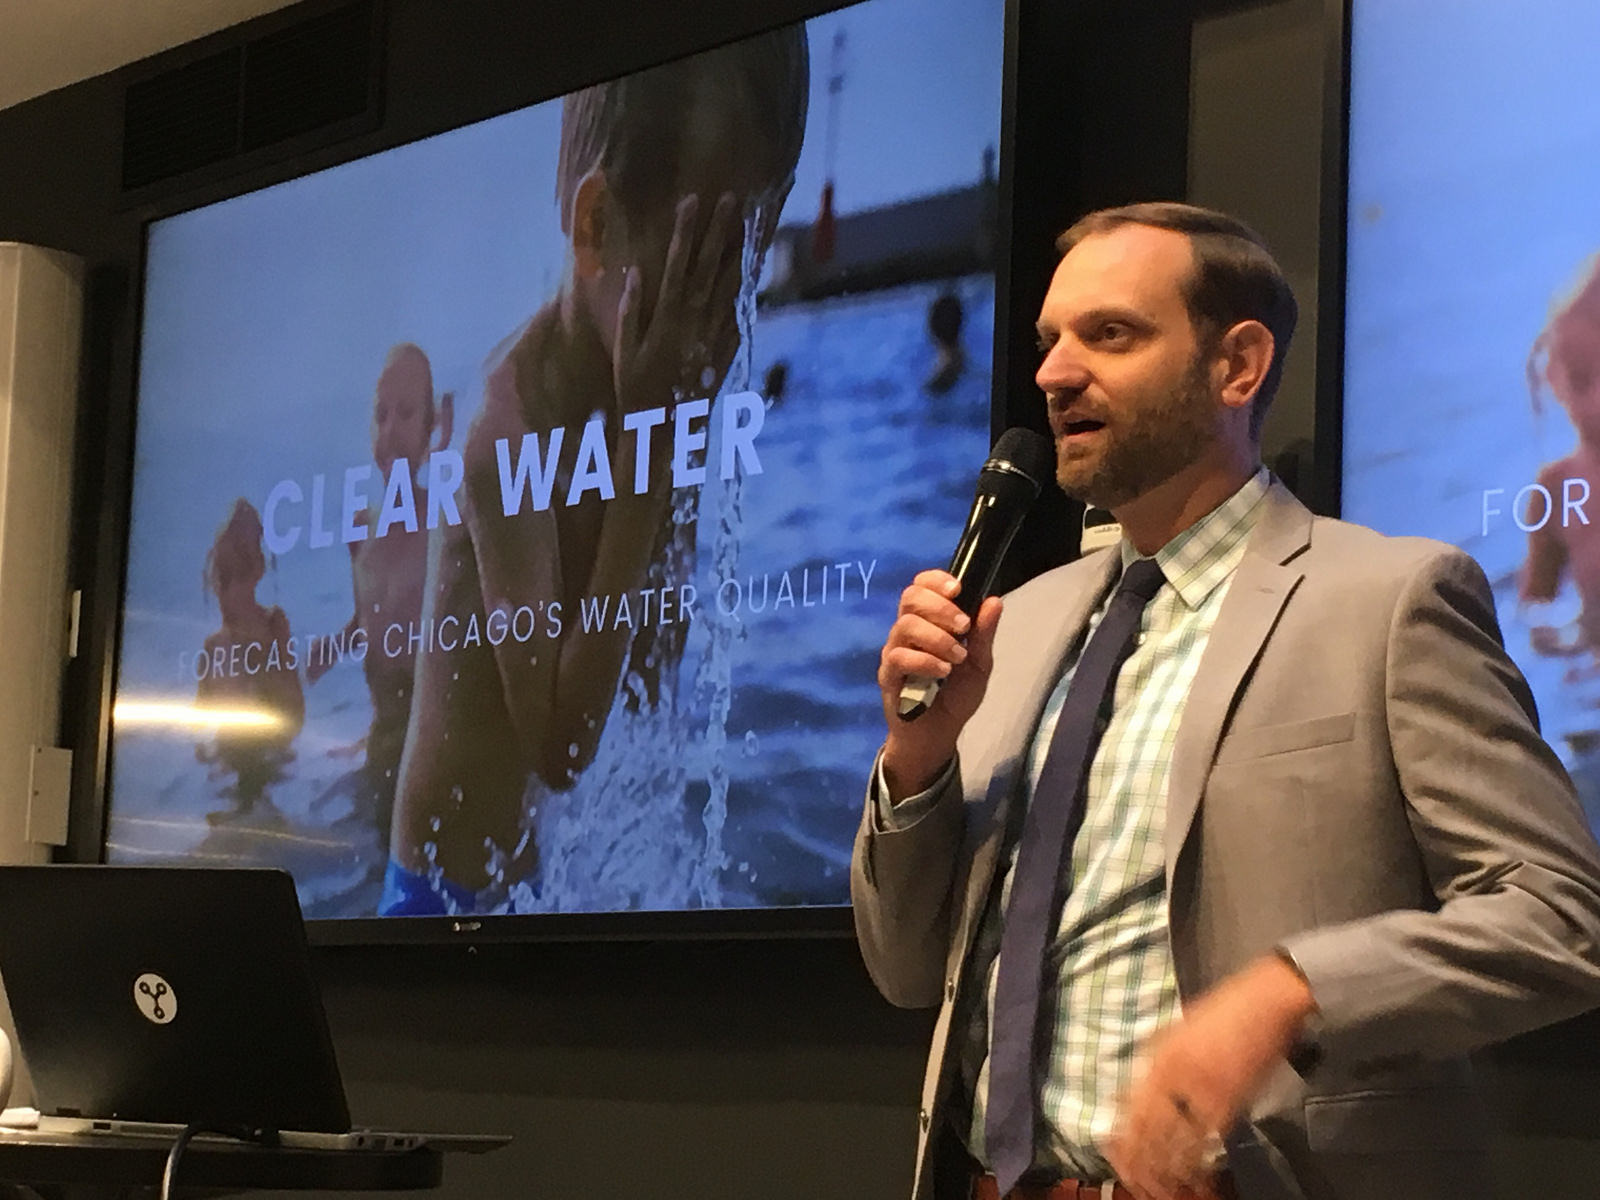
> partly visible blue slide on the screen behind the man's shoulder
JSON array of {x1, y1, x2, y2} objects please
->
[{"x1": 1342, "y1": 0, "x2": 1600, "y2": 827}]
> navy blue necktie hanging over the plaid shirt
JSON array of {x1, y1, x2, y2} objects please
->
[{"x1": 984, "y1": 558, "x2": 1163, "y2": 1195}]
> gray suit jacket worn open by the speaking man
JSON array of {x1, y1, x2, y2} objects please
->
[{"x1": 851, "y1": 485, "x2": 1600, "y2": 1200}]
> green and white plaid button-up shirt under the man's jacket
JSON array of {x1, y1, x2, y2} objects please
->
[{"x1": 960, "y1": 470, "x2": 1269, "y2": 1179}]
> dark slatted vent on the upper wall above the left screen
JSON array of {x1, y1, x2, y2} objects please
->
[{"x1": 122, "y1": 0, "x2": 378, "y2": 190}]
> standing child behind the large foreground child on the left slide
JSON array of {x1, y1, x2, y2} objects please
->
[{"x1": 306, "y1": 342, "x2": 454, "y2": 850}]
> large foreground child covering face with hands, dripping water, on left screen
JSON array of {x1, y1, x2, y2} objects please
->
[{"x1": 379, "y1": 27, "x2": 810, "y2": 914}]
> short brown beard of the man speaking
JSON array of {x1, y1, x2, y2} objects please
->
[{"x1": 1056, "y1": 354, "x2": 1216, "y2": 509}]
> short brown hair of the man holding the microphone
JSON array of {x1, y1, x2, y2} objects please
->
[{"x1": 1056, "y1": 202, "x2": 1299, "y2": 437}]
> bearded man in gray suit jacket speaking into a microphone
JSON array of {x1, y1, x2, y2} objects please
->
[{"x1": 853, "y1": 205, "x2": 1600, "y2": 1200}]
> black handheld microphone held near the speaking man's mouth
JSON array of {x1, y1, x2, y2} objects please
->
[{"x1": 896, "y1": 427, "x2": 1056, "y2": 722}]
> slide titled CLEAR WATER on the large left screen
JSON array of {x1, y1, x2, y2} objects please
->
[{"x1": 107, "y1": 0, "x2": 1005, "y2": 918}]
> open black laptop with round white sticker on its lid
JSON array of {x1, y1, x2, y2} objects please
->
[{"x1": 0, "y1": 864, "x2": 510, "y2": 1150}]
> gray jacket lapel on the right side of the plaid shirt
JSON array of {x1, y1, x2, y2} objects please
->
[{"x1": 1166, "y1": 482, "x2": 1312, "y2": 896}]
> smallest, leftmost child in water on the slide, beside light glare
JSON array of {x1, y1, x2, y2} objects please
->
[{"x1": 195, "y1": 499, "x2": 306, "y2": 813}]
